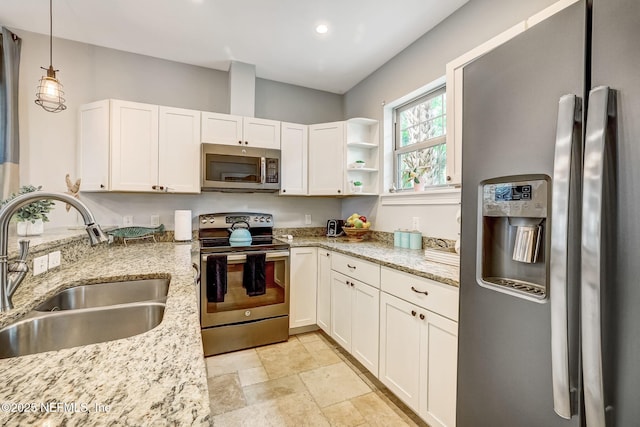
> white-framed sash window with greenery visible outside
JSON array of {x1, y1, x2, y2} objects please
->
[{"x1": 394, "y1": 86, "x2": 447, "y2": 190}]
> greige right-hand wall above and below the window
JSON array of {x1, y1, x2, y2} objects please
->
[{"x1": 342, "y1": 0, "x2": 555, "y2": 240}]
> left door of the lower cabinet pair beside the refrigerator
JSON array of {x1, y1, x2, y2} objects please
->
[{"x1": 379, "y1": 292, "x2": 420, "y2": 412}]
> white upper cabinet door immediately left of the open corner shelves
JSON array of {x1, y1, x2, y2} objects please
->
[{"x1": 309, "y1": 122, "x2": 345, "y2": 196}]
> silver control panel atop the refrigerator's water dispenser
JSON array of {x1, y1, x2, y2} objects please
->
[{"x1": 482, "y1": 180, "x2": 548, "y2": 218}]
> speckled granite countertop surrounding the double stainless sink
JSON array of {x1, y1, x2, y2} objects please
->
[{"x1": 0, "y1": 243, "x2": 210, "y2": 426}]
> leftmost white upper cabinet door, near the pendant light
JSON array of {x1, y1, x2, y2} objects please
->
[{"x1": 78, "y1": 99, "x2": 111, "y2": 191}]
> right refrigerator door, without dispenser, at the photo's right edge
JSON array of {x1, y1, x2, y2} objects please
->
[{"x1": 585, "y1": 0, "x2": 640, "y2": 427}]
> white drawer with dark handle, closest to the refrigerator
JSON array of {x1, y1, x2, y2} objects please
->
[{"x1": 380, "y1": 267, "x2": 458, "y2": 322}]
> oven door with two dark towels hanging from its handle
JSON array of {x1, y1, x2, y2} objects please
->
[{"x1": 200, "y1": 250, "x2": 289, "y2": 328}]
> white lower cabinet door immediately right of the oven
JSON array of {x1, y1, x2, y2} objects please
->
[{"x1": 289, "y1": 248, "x2": 318, "y2": 328}]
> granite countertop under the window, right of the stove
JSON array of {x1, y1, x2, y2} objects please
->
[{"x1": 281, "y1": 237, "x2": 460, "y2": 287}]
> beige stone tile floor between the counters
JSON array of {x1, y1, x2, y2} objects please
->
[{"x1": 206, "y1": 332, "x2": 426, "y2": 427}]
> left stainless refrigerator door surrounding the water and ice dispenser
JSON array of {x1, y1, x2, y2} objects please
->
[{"x1": 457, "y1": 2, "x2": 585, "y2": 427}]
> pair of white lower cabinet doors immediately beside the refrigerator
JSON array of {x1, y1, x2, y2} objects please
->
[{"x1": 379, "y1": 292, "x2": 458, "y2": 427}]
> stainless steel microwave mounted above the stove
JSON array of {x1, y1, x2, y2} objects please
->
[{"x1": 201, "y1": 144, "x2": 280, "y2": 192}]
